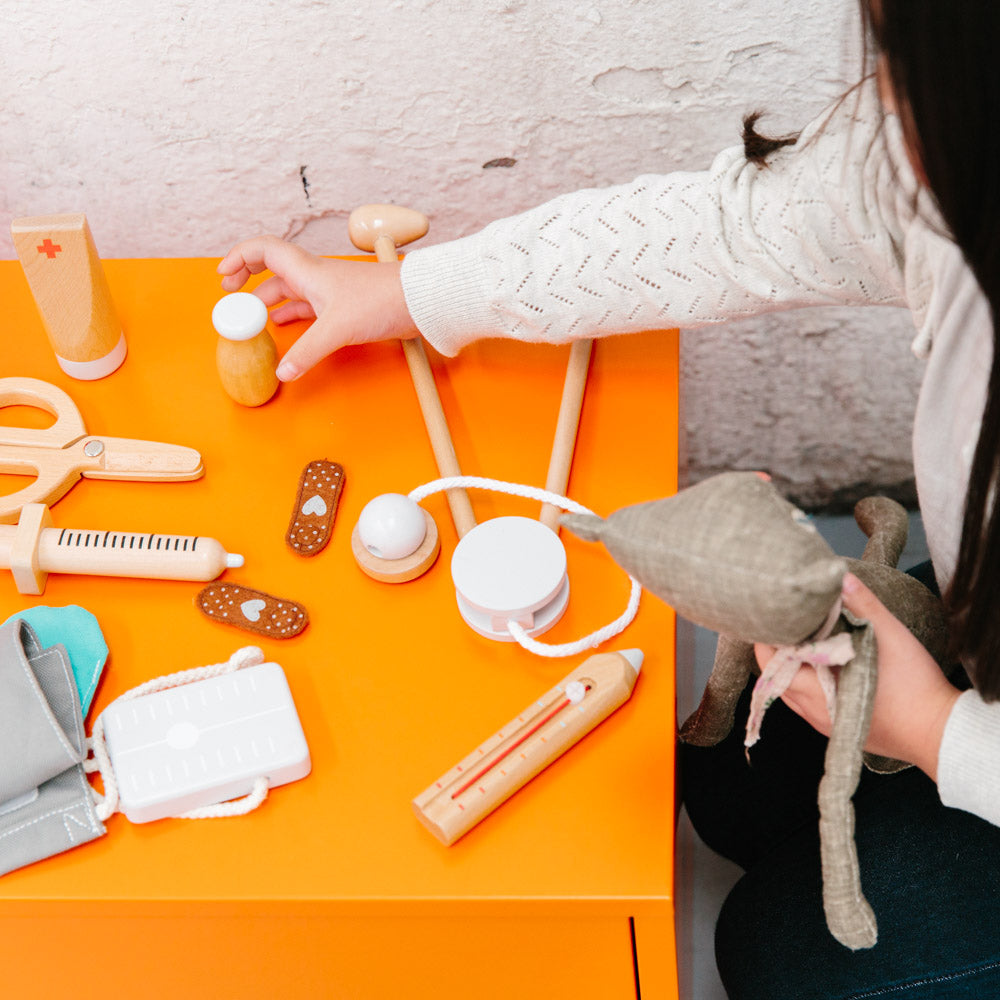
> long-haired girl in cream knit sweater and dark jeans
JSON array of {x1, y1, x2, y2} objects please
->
[{"x1": 219, "y1": 0, "x2": 1000, "y2": 1000}]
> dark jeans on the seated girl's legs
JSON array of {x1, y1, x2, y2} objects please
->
[{"x1": 679, "y1": 564, "x2": 1000, "y2": 1000}]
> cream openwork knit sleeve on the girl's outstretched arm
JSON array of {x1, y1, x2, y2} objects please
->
[{"x1": 402, "y1": 86, "x2": 909, "y2": 355}]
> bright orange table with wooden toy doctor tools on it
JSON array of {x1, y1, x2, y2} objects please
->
[{"x1": 0, "y1": 260, "x2": 677, "y2": 1000}]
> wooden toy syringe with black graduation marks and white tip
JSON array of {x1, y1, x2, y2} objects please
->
[{"x1": 0, "y1": 503, "x2": 243, "y2": 594}]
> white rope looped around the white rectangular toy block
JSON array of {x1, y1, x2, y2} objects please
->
[{"x1": 83, "y1": 646, "x2": 268, "y2": 822}]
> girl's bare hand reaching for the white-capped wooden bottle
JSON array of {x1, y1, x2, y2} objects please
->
[{"x1": 218, "y1": 236, "x2": 417, "y2": 382}]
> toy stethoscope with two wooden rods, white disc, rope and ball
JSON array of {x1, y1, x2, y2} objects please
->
[{"x1": 348, "y1": 205, "x2": 641, "y2": 657}]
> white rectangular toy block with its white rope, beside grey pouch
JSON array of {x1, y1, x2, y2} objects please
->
[{"x1": 89, "y1": 646, "x2": 311, "y2": 823}]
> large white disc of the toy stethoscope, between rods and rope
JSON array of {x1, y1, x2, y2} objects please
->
[{"x1": 451, "y1": 517, "x2": 569, "y2": 642}]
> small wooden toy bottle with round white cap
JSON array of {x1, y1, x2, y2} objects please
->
[{"x1": 212, "y1": 292, "x2": 278, "y2": 406}]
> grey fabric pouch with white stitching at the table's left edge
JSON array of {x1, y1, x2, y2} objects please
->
[{"x1": 0, "y1": 619, "x2": 105, "y2": 875}]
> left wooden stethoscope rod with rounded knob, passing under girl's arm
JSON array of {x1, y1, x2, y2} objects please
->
[{"x1": 348, "y1": 205, "x2": 476, "y2": 538}]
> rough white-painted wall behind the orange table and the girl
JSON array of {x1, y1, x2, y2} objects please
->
[{"x1": 0, "y1": 0, "x2": 919, "y2": 502}]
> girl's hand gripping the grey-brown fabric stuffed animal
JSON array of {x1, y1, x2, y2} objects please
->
[{"x1": 755, "y1": 573, "x2": 960, "y2": 781}]
